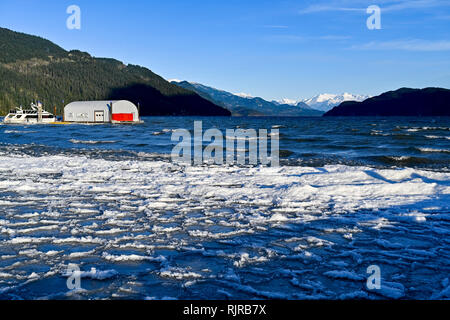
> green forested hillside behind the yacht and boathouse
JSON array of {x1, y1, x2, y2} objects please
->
[{"x1": 0, "y1": 28, "x2": 231, "y2": 116}]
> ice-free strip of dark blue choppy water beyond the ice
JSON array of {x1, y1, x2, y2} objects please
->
[{"x1": 0, "y1": 117, "x2": 450, "y2": 170}]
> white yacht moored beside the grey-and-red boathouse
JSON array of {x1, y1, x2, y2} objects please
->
[{"x1": 3, "y1": 103, "x2": 56, "y2": 124}]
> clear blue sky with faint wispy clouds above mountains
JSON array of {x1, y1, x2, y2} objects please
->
[{"x1": 0, "y1": 0, "x2": 450, "y2": 99}]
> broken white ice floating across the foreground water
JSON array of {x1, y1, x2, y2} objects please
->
[{"x1": 0, "y1": 156, "x2": 450, "y2": 299}]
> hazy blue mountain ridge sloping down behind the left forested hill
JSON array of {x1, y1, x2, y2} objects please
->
[{"x1": 171, "y1": 80, "x2": 323, "y2": 117}]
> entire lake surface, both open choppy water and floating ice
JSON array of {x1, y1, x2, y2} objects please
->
[{"x1": 0, "y1": 117, "x2": 450, "y2": 299}]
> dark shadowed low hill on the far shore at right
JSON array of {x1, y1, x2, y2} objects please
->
[{"x1": 324, "y1": 88, "x2": 450, "y2": 117}]
